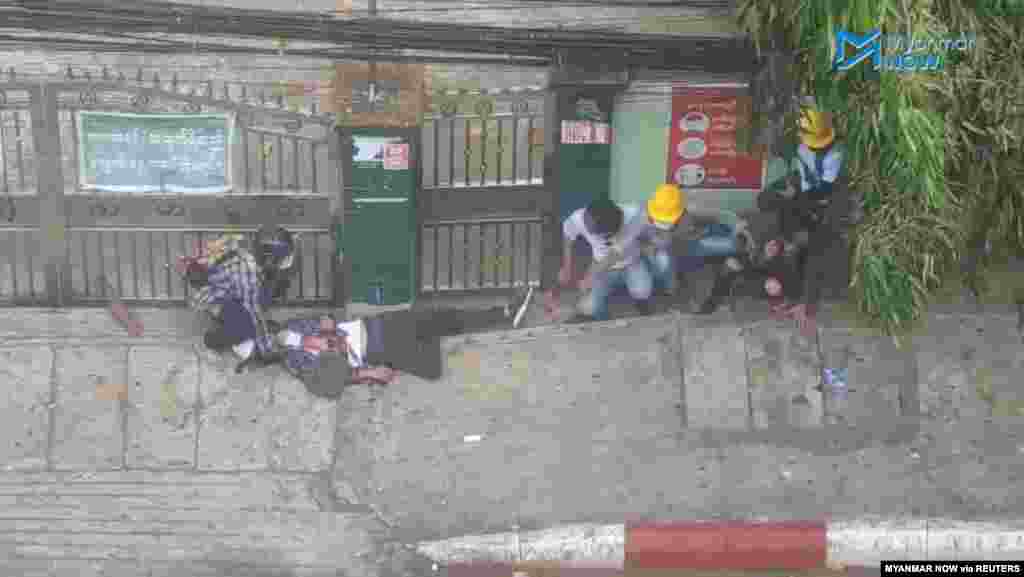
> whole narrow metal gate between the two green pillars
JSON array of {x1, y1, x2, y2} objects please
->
[{"x1": 419, "y1": 102, "x2": 550, "y2": 294}]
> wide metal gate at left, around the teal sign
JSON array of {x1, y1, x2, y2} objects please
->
[{"x1": 0, "y1": 79, "x2": 340, "y2": 305}]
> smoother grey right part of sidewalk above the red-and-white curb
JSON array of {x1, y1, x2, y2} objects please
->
[{"x1": 327, "y1": 311, "x2": 1024, "y2": 553}]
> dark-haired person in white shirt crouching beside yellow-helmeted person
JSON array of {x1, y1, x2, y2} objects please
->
[{"x1": 545, "y1": 199, "x2": 636, "y2": 317}]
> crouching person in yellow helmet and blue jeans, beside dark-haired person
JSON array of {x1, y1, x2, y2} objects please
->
[{"x1": 575, "y1": 184, "x2": 694, "y2": 320}]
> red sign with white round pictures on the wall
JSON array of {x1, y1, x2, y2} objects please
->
[{"x1": 668, "y1": 87, "x2": 762, "y2": 190}]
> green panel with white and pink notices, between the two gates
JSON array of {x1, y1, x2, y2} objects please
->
[{"x1": 341, "y1": 128, "x2": 420, "y2": 304}]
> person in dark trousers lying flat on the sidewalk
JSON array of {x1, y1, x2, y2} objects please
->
[{"x1": 275, "y1": 290, "x2": 532, "y2": 398}]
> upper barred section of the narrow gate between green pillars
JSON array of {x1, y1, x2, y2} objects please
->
[{"x1": 423, "y1": 108, "x2": 544, "y2": 189}]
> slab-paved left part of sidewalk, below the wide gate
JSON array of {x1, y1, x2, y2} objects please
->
[{"x1": 0, "y1": 310, "x2": 423, "y2": 577}]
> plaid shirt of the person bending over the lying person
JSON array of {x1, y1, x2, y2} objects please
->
[{"x1": 191, "y1": 250, "x2": 273, "y2": 354}]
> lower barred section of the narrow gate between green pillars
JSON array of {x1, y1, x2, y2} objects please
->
[{"x1": 420, "y1": 216, "x2": 549, "y2": 294}]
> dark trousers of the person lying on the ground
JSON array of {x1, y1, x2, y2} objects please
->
[{"x1": 362, "y1": 307, "x2": 508, "y2": 380}]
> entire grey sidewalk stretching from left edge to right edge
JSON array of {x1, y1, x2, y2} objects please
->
[{"x1": 0, "y1": 310, "x2": 1024, "y2": 577}]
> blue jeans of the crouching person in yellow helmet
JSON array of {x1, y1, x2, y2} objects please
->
[{"x1": 580, "y1": 250, "x2": 676, "y2": 321}]
